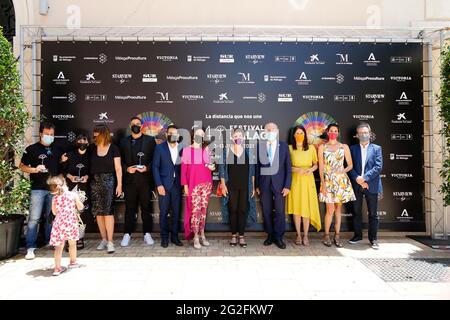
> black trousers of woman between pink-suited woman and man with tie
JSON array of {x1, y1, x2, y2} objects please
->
[{"x1": 228, "y1": 188, "x2": 248, "y2": 236}]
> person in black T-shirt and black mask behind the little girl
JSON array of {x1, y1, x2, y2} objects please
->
[{"x1": 61, "y1": 133, "x2": 89, "y2": 251}]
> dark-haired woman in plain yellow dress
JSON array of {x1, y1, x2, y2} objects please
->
[{"x1": 286, "y1": 126, "x2": 321, "y2": 246}]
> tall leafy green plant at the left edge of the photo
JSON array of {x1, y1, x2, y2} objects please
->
[{"x1": 0, "y1": 27, "x2": 30, "y2": 219}]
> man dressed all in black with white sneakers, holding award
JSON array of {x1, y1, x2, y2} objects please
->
[{"x1": 120, "y1": 117, "x2": 155, "y2": 247}]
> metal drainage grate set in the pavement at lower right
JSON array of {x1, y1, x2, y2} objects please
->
[{"x1": 358, "y1": 258, "x2": 450, "y2": 282}]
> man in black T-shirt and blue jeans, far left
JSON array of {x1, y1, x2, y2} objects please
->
[{"x1": 19, "y1": 122, "x2": 62, "y2": 260}]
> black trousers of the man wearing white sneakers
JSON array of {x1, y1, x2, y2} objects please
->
[{"x1": 125, "y1": 181, "x2": 153, "y2": 235}]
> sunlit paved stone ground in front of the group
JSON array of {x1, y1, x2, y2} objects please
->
[{"x1": 0, "y1": 234, "x2": 450, "y2": 299}]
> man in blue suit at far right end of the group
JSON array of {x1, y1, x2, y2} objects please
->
[{"x1": 349, "y1": 123, "x2": 383, "y2": 249}]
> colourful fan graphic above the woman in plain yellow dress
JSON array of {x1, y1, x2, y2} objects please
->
[{"x1": 295, "y1": 111, "x2": 336, "y2": 145}]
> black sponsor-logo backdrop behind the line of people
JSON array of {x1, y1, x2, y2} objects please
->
[{"x1": 41, "y1": 41, "x2": 425, "y2": 231}]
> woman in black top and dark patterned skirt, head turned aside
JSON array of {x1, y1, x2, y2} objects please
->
[{"x1": 90, "y1": 125, "x2": 122, "y2": 253}]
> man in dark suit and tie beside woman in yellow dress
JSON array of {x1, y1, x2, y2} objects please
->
[{"x1": 256, "y1": 122, "x2": 292, "y2": 249}]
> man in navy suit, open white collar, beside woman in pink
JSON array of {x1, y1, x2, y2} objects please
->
[{"x1": 152, "y1": 124, "x2": 183, "y2": 248}]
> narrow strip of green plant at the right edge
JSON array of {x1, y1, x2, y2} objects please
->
[{"x1": 438, "y1": 46, "x2": 450, "y2": 206}]
